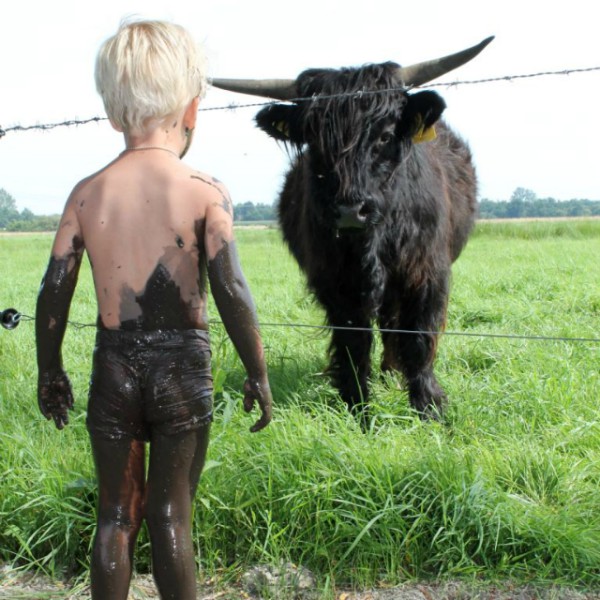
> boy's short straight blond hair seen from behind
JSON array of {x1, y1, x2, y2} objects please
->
[{"x1": 95, "y1": 21, "x2": 206, "y2": 132}]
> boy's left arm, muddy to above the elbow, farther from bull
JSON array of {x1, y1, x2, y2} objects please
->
[{"x1": 35, "y1": 200, "x2": 84, "y2": 429}]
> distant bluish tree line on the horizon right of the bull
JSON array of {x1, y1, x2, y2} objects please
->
[{"x1": 479, "y1": 188, "x2": 600, "y2": 219}]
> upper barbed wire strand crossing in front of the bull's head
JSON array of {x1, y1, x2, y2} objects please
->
[{"x1": 0, "y1": 66, "x2": 600, "y2": 138}]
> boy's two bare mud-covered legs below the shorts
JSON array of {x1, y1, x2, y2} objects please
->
[{"x1": 91, "y1": 424, "x2": 210, "y2": 600}]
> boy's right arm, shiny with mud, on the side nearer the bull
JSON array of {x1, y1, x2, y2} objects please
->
[{"x1": 204, "y1": 178, "x2": 272, "y2": 432}]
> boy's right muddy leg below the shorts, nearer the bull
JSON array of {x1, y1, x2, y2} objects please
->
[{"x1": 146, "y1": 424, "x2": 210, "y2": 600}]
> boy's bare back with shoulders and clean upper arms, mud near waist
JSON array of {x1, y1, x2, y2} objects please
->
[{"x1": 53, "y1": 148, "x2": 233, "y2": 330}]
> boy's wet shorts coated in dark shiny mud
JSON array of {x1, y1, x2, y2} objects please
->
[{"x1": 86, "y1": 329, "x2": 213, "y2": 441}]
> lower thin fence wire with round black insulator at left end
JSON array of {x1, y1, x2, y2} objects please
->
[{"x1": 3, "y1": 309, "x2": 600, "y2": 344}]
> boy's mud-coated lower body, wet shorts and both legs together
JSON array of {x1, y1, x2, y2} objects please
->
[{"x1": 86, "y1": 330, "x2": 212, "y2": 599}]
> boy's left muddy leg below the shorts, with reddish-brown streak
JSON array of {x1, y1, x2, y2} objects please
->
[{"x1": 91, "y1": 436, "x2": 144, "y2": 600}]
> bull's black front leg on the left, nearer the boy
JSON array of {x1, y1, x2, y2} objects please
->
[{"x1": 328, "y1": 314, "x2": 373, "y2": 425}]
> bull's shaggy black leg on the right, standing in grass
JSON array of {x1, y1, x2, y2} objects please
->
[{"x1": 380, "y1": 286, "x2": 447, "y2": 418}]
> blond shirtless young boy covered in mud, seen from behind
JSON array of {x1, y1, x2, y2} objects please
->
[{"x1": 36, "y1": 21, "x2": 271, "y2": 600}]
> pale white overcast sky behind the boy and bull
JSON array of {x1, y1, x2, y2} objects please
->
[{"x1": 0, "y1": 0, "x2": 600, "y2": 214}]
